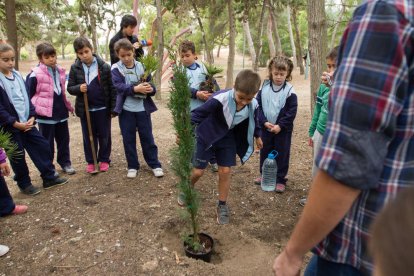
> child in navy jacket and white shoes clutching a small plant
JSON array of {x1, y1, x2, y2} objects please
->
[{"x1": 112, "y1": 39, "x2": 164, "y2": 178}]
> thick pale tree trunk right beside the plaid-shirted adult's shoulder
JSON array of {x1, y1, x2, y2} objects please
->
[{"x1": 308, "y1": 0, "x2": 327, "y2": 113}]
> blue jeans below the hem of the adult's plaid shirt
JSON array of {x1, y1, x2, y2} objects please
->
[{"x1": 304, "y1": 255, "x2": 364, "y2": 276}]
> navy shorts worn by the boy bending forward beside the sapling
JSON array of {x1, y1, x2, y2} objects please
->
[{"x1": 193, "y1": 130, "x2": 236, "y2": 169}]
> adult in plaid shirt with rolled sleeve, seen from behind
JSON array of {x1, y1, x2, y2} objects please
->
[{"x1": 273, "y1": 0, "x2": 414, "y2": 275}]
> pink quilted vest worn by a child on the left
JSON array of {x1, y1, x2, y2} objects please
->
[{"x1": 32, "y1": 63, "x2": 73, "y2": 117}]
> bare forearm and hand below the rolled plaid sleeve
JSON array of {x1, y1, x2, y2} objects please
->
[{"x1": 273, "y1": 170, "x2": 361, "y2": 276}]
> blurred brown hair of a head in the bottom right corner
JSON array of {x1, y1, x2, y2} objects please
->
[{"x1": 368, "y1": 187, "x2": 414, "y2": 276}]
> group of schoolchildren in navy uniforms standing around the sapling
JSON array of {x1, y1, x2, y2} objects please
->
[{"x1": 0, "y1": 13, "x2": 336, "y2": 244}]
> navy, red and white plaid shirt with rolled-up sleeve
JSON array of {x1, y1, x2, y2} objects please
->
[{"x1": 313, "y1": 0, "x2": 414, "y2": 273}]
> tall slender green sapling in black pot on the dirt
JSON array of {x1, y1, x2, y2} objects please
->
[{"x1": 169, "y1": 65, "x2": 214, "y2": 262}]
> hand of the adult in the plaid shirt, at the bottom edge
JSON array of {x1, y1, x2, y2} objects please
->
[{"x1": 273, "y1": 249, "x2": 303, "y2": 276}]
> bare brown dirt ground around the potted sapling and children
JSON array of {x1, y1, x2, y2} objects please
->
[{"x1": 0, "y1": 50, "x2": 312, "y2": 275}]
